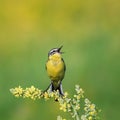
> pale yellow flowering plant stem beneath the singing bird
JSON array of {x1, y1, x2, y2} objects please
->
[{"x1": 10, "y1": 85, "x2": 100, "y2": 120}]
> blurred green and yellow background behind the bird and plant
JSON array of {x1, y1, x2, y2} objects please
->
[{"x1": 0, "y1": 0, "x2": 120, "y2": 120}]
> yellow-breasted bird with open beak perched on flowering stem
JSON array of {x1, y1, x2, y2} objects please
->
[{"x1": 46, "y1": 46, "x2": 66, "y2": 96}]
